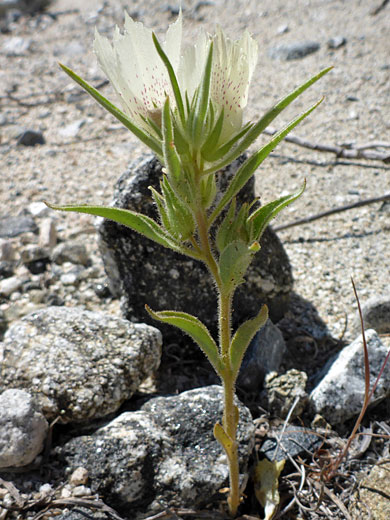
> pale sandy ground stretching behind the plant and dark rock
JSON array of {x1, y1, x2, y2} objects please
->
[{"x1": 0, "y1": 0, "x2": 390, "y2": 337}]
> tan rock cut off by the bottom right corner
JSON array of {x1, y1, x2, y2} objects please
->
[{"x1": 349, "y1": 459, "x2": 390, "y2": 520}]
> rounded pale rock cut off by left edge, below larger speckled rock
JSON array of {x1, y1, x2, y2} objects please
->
[{"x1": 0, "y1": 388, "x2": 49, "y2": 468}]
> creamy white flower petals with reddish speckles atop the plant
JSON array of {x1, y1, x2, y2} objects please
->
[{"x1": 94, "y1": 12, "x2": 257, "y2": 140}]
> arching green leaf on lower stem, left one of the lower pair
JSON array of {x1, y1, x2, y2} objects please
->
[{"x1": 145, "y1": 305, "x2": 224, "y2": 375}]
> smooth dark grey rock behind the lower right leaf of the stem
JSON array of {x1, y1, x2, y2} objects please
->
[{"x1": 237, "y1": 320, "x2": 286, "y2": 391}]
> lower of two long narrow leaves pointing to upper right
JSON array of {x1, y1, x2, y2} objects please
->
[{"x1": 209, "y1": 98, "x2": 323, "y2": 225}]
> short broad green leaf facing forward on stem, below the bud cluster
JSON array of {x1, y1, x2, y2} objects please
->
[{"x1": 218, "y1": 240, "x2": 254, "y2": 291}]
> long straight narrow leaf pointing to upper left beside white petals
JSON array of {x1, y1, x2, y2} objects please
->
[{"x1": 60, "y1": 63, "x2": 162, "y2": 157}]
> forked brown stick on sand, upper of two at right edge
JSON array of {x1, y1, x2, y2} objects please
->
[{"x1": 264, "y1": 127, "x2": 390, "y2": 164}]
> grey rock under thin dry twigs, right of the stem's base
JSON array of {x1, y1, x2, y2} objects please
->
[{"x1": 259, "y1": 425, "x2": 323, "y2": 461}]
